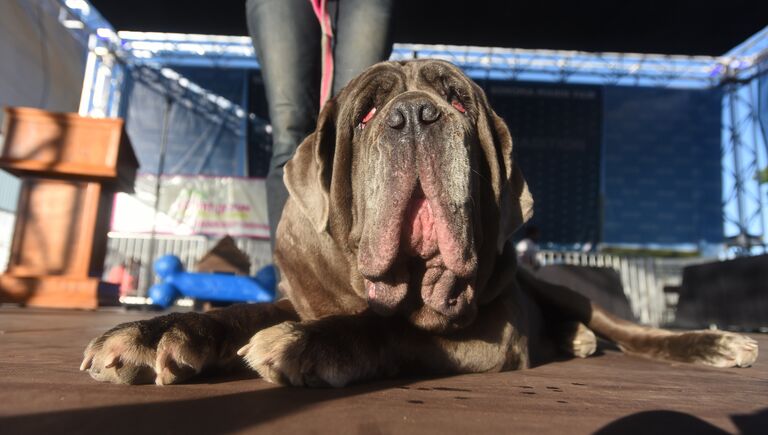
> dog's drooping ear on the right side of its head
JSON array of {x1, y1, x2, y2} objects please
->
[{"x1": 475, "y1": 86, "x2": 533, "y2": 253}]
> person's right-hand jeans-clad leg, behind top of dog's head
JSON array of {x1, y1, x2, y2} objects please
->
[{"x1": 333, "y1": 0, "x2": 394, "y2": 95}]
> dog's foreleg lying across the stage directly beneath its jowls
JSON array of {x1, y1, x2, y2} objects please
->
[{"x1": 238, "y1": 294, "x2": 528, "y2": 387}]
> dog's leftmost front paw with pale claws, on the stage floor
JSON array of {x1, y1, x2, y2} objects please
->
[{"x1": 80, "y1": 313, "x2": 223, "y2": 385}]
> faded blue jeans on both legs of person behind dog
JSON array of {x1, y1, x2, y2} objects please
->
[{"x1": 246, "y1": 0, "x2": 394, "y2": 249}]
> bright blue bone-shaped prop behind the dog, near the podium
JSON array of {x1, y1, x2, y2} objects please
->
[{"x1": 149, "y1": 255, "x2": 275, "y2": 308}]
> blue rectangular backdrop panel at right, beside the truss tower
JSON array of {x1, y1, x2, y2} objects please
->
[{"x1": 602, "y1": 86, "x2": 723, "y2": 245}]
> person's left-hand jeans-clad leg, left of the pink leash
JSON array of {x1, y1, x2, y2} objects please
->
[{"x1": 246, "y1": 0, "x2": 320, "y2": 250}]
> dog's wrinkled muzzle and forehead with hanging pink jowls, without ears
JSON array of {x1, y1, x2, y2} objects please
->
[{"x1": 346, "y1": 62, "x2": 484, "y2": 324}]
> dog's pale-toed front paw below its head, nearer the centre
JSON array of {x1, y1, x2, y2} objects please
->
[{"x1": 237, "y1": 322, "x2": 353, "y2": 387}]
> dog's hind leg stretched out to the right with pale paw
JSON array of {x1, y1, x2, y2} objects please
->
[{"x1": 517, "y1": 267, "x2": 758, "y2": 367}]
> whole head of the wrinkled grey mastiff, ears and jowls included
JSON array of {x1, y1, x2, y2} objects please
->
[{"x1": 287, "y1": 61, "x2": 531, "y2": 331}]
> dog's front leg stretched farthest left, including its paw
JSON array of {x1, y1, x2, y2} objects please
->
[{"x1": 80, "y1": 300, "x2": 298, "y2": 385}]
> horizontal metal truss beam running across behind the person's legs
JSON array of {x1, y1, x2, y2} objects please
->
[{"x1": 118, "y1": 32, "x2": 728, "y2": 88}]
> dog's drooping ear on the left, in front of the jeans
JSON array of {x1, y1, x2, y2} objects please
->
[{"x1": 283, "y1": 100, "x2": 336, "y2": 233}]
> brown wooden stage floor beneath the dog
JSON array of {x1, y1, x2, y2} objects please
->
[{"x1": 0, "y1": 307, "x2": 768, "y2": 435}]
